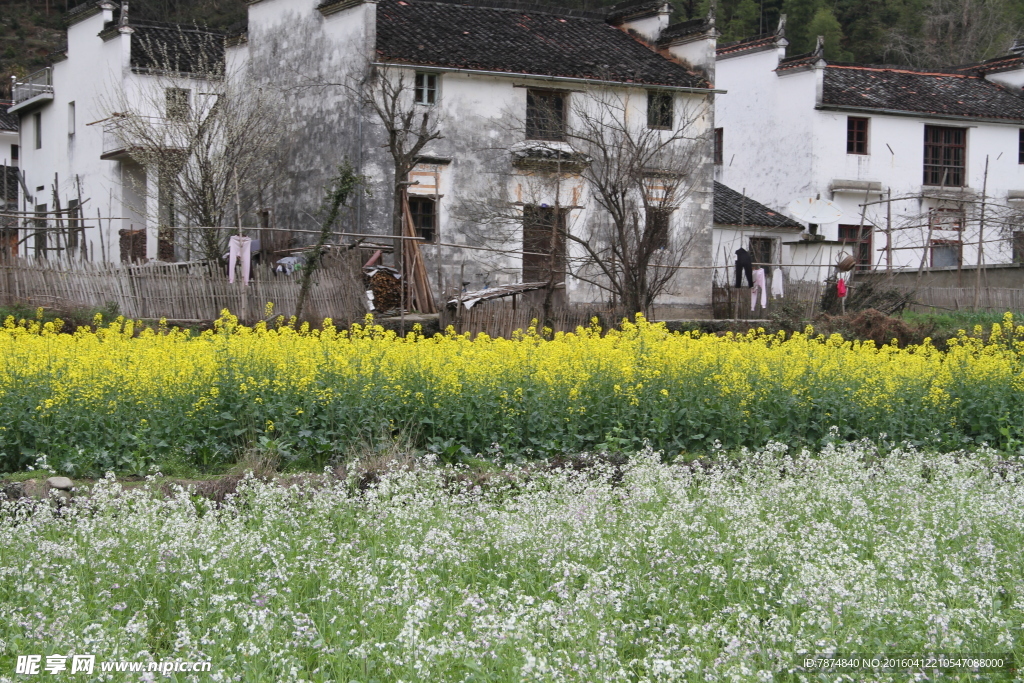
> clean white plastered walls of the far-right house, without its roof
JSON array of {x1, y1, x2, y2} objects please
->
[{"x1": 716, "y1": 51, "x2": 1024, "y2": 278}]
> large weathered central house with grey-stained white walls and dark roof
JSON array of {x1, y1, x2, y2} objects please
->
[{"x1": 227, "y1": 0, "x2": 715, "y2": 309}]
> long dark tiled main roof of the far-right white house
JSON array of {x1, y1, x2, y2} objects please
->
[{"x1": 821, "y1": 65, "x2": 1024, "y2": 121}]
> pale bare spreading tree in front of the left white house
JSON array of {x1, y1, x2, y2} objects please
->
[{"x1": 104, "y1": 28, "x2": 283, "y2": 258}]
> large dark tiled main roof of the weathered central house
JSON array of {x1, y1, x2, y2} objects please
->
[{"x1": 377, "y1": 0, "x2": 709, "y2": 88}]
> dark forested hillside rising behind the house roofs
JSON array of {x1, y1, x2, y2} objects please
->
[{"x1": 0, "y1": 0, "x2": 1024, "y2": 97}]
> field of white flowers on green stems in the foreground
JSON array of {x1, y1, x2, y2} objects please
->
[{"x1": 0, "y1": 443, "x2": 1024, "y2": 682}]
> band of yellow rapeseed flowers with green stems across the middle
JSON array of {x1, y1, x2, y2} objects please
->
[{"x1": 0, "y1": 311, "x2": 1024, "y2": 471}]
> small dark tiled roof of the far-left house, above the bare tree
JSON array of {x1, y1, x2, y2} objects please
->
[{"x1": 131, "y1": 23, "x2": 224, "y2": 74}]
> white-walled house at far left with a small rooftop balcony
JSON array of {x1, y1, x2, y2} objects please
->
[{"x1": 7, "y1": 0, "x2": 223, "y2": 261}]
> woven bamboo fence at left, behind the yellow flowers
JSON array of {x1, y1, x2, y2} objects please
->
[{"x1": 0, "y1": 252, "x2": 367, "y2": 325}]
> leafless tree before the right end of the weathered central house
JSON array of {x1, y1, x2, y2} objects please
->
[{"x1": 566, "y1": 90, "x2": 712, "y2": 312}]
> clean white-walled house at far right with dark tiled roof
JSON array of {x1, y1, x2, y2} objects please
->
[{"x1": 716, "y1": 20, "x2": 1024, "y2": 280}]
